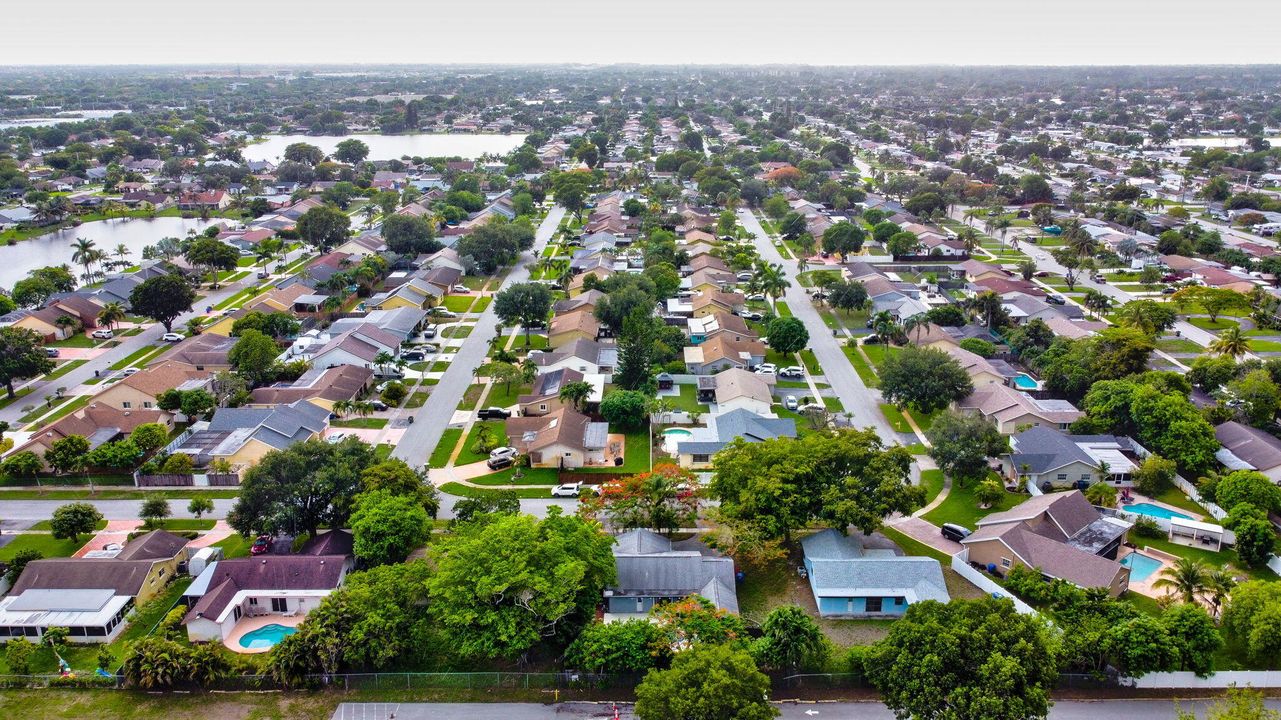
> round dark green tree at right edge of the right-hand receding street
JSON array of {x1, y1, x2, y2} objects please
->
[{"x1": 880, "y1": 345, "x2": 974, "y2": 413}]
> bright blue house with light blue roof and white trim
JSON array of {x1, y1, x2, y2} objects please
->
[{"x1": 801, "y1": 530, "x2": 949, "y2": 618}]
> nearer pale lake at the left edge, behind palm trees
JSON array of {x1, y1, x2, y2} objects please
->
[{"x1": 0, "y1": 218, "x2": 217, "y2": 288}]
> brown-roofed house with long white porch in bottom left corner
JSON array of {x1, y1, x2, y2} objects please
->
[{"x1": 0, "y1": 530, "x2": 187, "y2": 643}]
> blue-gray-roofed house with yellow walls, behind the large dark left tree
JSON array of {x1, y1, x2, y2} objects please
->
[{"x1": 174, "y1": 400, "x2": 329, "y2": 468}]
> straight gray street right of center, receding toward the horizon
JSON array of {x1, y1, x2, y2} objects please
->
[{"x1": 738, "y1": 204, "x2": 898, "y2": 438}]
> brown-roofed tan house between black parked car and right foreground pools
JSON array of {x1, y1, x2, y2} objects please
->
[{"x1": 961, "y1": 491, "x2": 1131, "y2": 597}]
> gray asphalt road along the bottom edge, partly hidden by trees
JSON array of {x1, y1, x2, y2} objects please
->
[{"x1": 332, "y1": 700, "x2": 1281, "y2": 720}]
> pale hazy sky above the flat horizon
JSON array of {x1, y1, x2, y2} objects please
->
[{"x1": 0, "y1": 0, "x2": 1281, "y2": 65}]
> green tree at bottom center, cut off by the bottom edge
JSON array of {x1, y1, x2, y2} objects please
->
[{"x1": 635, "y1": 644, "x2": 779, "y2": 720}]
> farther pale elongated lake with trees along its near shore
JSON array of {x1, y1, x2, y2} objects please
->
[{"x1": 242, "y1": 132, "x2": 525, "y2": 163}]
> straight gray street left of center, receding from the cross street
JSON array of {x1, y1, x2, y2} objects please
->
[{"x1": 392, "y1": 205, "x2": 565, "y2": 468}]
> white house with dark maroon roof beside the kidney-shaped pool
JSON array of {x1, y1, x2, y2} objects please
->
[{"x1": 182, "y1": 550, "x2": 352, "y2": 642}]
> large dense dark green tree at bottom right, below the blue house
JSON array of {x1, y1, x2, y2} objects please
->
[{"x1": 863, "y1": 598, "x2": 1059, "y2": 720}]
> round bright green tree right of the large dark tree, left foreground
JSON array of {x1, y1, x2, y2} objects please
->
[{"x1": 351, "y1": 489, "x2": 432, "y2": 565}]
